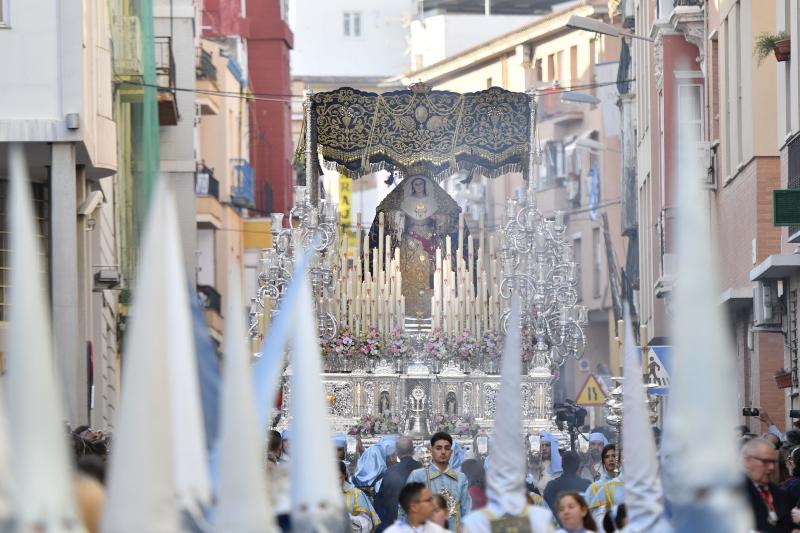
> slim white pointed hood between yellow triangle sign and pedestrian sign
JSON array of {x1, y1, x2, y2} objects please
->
[{"x1": 622, "y1": 304, "x2": 671, "y2": 533}]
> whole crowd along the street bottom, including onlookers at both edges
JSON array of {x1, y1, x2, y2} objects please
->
[{"x1": 65, "y1": 396, "x2": 800, "y2": 533}]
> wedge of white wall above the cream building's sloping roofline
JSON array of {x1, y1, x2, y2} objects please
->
[{"x1": 410, "y1": 13, "x2": 540, "y2": 70}]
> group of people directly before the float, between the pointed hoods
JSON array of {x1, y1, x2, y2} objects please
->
[{"x1": 278, "y1": 432, "x2": 625, "y2": 533}]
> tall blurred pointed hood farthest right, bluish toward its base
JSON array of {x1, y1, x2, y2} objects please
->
[{"x1": 662, "y1": 116, "x2": 751, "y2": 533}]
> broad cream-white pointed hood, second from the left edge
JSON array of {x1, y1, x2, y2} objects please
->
[{"x1": 102, "y1": 184, "x2": 183, "y2": 533}]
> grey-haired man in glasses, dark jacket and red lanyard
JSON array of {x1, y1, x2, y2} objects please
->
[{"x1": 742, "y1": 439, "x2": 793, "y2": 533}]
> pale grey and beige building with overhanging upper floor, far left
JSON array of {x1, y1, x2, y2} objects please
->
[{"x1": 0, "y1": 0, "x2": 121, "y2": 426}]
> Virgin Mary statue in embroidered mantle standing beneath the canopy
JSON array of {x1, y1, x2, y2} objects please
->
[{"x1": 370, "y1": 176, "x2": 466, "y2": 317}]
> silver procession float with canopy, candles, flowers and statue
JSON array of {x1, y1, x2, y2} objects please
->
[{"x1": 250, "y1": 84, "x2": 587, "y2": 454}]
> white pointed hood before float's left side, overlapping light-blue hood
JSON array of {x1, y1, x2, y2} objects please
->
[{"x1": 289, "y1": 269, "x2": 350, "y2": 533}]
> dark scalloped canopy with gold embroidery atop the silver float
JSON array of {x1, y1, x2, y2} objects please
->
[{"x1": 296, "y1": 84, "x2": 531, "y2": 179}]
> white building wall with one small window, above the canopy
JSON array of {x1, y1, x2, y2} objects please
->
[{"x1": 289, "y1": 0, "x2": 416, "y2": 77}]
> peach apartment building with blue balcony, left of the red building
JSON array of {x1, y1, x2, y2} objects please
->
[{"x1": 194, "y1": 37, "x2": 255, "y2": 344}]
